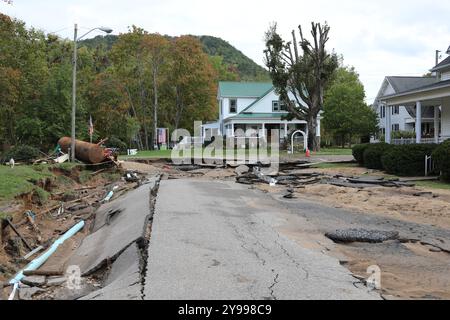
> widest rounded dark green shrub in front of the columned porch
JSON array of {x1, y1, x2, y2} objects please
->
[{"x1": 381, "y1": 144, "x2": 437, "y2": 176}]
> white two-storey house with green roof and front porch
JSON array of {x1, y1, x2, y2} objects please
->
[{"x1": 202, "y1": 82, "x2": 314, "y2": 140}]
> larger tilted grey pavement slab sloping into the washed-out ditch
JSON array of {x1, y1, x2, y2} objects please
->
[{"x1": 68, "y1": 177, "x2": 157, "y2": 275}]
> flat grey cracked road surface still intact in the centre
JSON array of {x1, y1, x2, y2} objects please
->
[{"x1": 143, "y1": 179, "x2": 379, "y2": 300}]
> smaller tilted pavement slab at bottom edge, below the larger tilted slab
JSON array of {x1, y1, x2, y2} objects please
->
[{"x1": 80, "y1": 244, "x2": 141, "y2": 300}]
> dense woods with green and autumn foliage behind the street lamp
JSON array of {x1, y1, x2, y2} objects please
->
[{"x1": 0, "y1": 14, "x2": 260, "y2": 152}]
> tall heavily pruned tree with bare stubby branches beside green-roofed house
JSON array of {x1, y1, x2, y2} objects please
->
[{"x1": 264, "y1": 22, "x2": 338, "y2": 151}]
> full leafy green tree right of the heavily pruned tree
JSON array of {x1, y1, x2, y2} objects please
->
[{"x1": 323, "y1": 67, "x2": 378, "y2": 146}]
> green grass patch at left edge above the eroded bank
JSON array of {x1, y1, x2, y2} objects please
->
[{"x1": 0, "y1": 165, "x2": 54, "y2": 200}]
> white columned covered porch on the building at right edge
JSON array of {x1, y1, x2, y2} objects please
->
[{"x1": 381, "y1": 81, "x2": 450, "y2": 143}]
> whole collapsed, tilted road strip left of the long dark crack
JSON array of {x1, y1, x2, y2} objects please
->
[{"x1": 68, "y1": 176, "x2": 160, "y2": 300}]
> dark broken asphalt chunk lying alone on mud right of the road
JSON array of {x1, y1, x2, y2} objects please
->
[{"x1": 325, "y1": 229, "x2": 399, "y2": 243}]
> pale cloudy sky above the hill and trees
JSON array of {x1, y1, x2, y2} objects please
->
[{"x1": 0, "y1": 0, "x2": 450, "y2": 103}]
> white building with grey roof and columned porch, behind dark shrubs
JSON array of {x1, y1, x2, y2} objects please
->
[{"x1": 373, "y1": 48, "x2": 450, "y2": 143}]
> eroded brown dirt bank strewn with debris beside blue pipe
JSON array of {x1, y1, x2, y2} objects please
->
[{"x1": 0, "y1": 166, "x2": 121, "y2": 283}]
